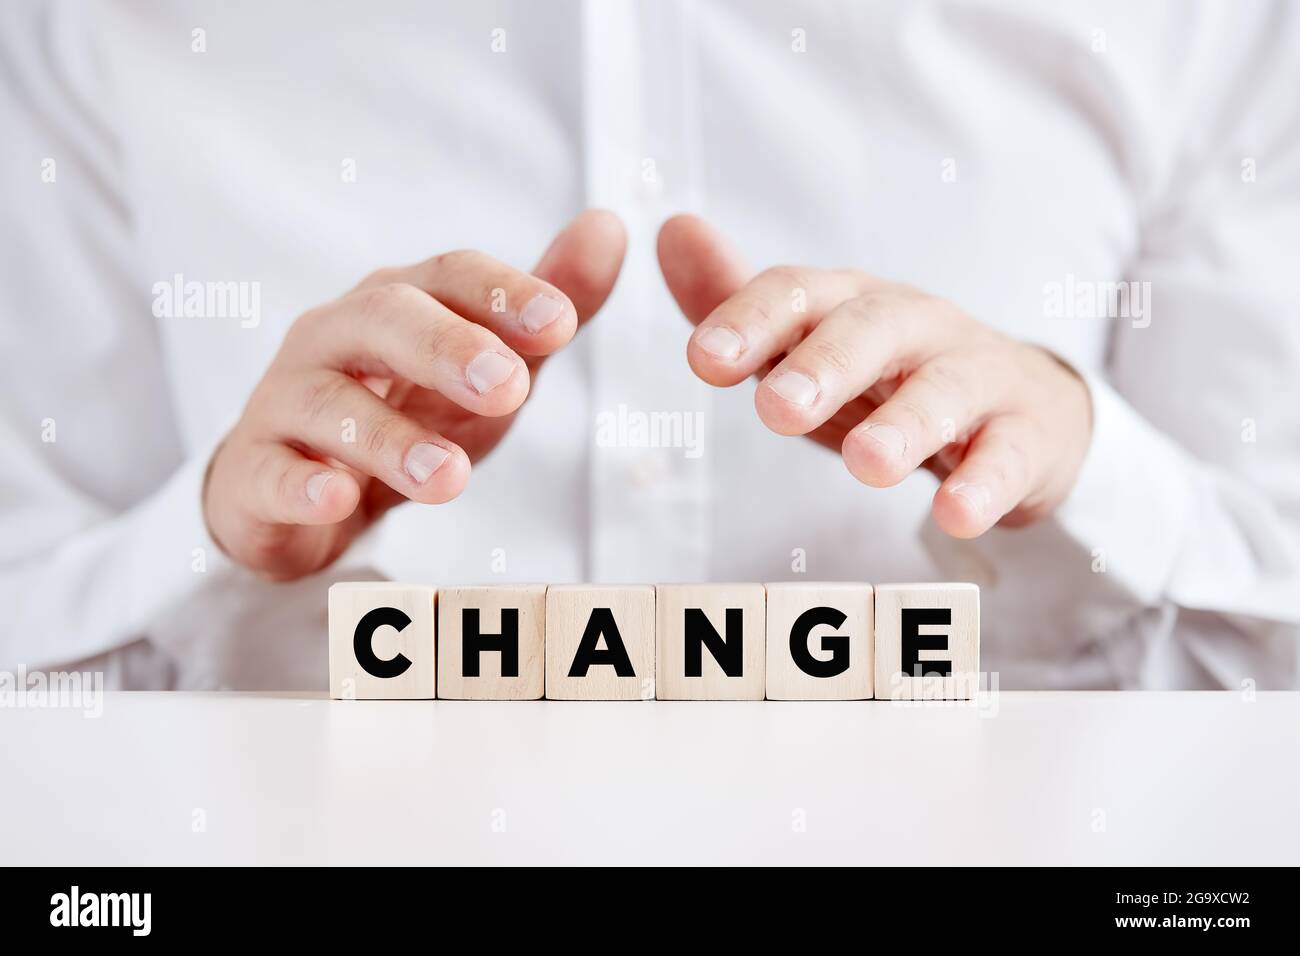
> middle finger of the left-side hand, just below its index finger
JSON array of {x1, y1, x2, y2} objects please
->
[{"x1": 290, "y1": 282, "x2": 529, "y2": 416}]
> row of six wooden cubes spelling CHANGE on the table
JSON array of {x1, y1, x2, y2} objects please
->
[{"x1": 329, "y1": 581, "x2": 979, "y2": 700}]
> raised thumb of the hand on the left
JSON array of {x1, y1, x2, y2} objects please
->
[{"x1": 533, "y1": 209, "x2": 628, "y2": 325}]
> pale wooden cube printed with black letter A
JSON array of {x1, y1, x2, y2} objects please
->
[{"x1": 546, "y1": 584, "x2": 655, "y2": 700}]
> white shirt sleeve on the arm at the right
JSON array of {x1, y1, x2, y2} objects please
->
[{"x1": 927, "y1": 4, "x2": 1300, "y2": 688}]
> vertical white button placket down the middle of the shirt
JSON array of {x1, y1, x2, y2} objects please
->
[{"x1": 582, "y1": 0, "x2": 711, "y2": 581}]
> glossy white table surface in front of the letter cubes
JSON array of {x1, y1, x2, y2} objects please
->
[{"x1": 0, "y1": 692, "x2": 1300, "y2": 865}]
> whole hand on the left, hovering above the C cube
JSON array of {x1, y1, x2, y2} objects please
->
[{"x1": 203, "y1": 209, "x2": 627, "y2": 580}]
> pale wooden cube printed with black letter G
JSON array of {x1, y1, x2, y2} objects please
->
[{"x1": 767, "y1": 581, "x2": 875, "y2": 700}]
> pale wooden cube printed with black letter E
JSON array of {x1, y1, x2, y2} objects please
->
[{"x1": 876, "y1": 584, "x2": 979, "y2": 700}]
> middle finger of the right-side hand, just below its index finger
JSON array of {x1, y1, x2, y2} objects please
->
[{"x1": 754, "y1": 291, "x2": 952, "y2": 434}]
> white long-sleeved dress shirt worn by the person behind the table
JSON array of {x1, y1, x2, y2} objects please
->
[{"x1": 0, "y1": 0, "x2": 1300, "y2": 689}]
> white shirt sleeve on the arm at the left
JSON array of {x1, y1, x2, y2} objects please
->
[{"x1": 0, "y1": 3, "x2": 239, "y2": 670}]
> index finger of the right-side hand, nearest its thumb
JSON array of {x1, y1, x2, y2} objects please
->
[{"x1": 686, "y1": 265, "x2": 863, "y2": 386}]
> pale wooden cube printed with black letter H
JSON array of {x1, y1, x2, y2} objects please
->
[{"x1": 438, "y1": 584, "x2": 546, "y2": 700}]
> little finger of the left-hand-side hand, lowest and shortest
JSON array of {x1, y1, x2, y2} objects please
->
[{"x1": 241, "y1": 441, "x2": 361, "y2": 524}]
